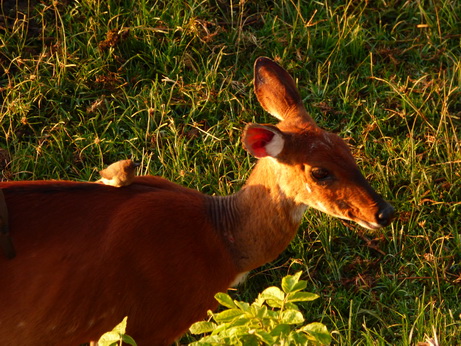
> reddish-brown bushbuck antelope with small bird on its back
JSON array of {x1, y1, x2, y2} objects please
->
[{"x1": 0, "y1": 57, "x2": 394, "y2": 346}]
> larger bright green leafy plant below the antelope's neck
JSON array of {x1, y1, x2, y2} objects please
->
[{"x1": 190, "y1": 272, "x2": 331, "y2": 345}]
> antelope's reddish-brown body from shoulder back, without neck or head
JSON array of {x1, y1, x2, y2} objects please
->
[{"x1": 0, "y1": 177, "x2": 237, "y2": 345}]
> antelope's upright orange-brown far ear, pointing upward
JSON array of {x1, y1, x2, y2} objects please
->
[{"x1": 254, "y1": 57, "x2": 314, "y2": 124}]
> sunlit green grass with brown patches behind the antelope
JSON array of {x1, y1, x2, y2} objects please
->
[{"x1": 0, "y1": 0, "x2": 461, "y2": 345}]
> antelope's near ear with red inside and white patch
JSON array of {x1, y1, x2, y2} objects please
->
[{"x1": 242, "y1": 124, "x2": 285, "y2": 158}]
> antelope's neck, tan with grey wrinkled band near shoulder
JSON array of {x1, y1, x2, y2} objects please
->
[{"x1": 209, "y1": 159, "x2": 306, "y2": 272}]
